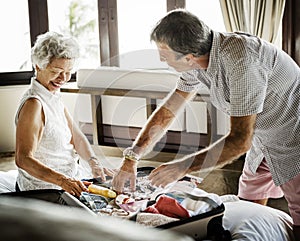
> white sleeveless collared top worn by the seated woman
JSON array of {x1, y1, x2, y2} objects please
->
[{"x1": 15, "y1": 78, "x2": 78, "y2": 191}]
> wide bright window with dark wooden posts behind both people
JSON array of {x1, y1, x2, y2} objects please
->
[{"x1": 0, "y1": 0, "x2": 300, "y2": 85}]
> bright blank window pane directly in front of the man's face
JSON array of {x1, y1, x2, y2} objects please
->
[{"x1": 117, "y1": 0, "x2": 168, "y2": 69}]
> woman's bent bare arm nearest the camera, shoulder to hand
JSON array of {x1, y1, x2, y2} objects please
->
[{"x1": 16, "y1": 99, "x2": 87, "y2": 196}]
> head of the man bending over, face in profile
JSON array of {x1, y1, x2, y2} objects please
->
[{"x1": 150, "y1": 10, "x2": 212, "y2": 72}]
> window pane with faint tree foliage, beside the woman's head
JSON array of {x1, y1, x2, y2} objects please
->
[{"x1": 48, "y1": 0, "x2": 100, "y2": 68}]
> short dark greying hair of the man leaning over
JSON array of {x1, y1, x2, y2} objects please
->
[{"x1": 150, "y1": 9, "x2": 213, "y2": 57}]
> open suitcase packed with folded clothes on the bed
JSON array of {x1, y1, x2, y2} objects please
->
[{"x1": 80, "y1": 167, "x2": 231, "y2": 241}]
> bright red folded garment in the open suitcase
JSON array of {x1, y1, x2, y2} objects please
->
[{"x1": 144, "y1": 195, "x2": 190, "y2": 218}]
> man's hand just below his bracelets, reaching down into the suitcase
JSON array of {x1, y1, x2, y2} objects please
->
[{"x1": 112, "y1": 158, "x2": 137, "y2": 193}]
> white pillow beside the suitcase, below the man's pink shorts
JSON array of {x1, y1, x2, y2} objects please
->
[{"x1": 223, "y1": 200, "x2": 293, "y2": 241}]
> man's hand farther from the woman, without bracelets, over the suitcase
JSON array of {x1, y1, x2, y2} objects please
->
[{"x1": 149, "y1": 160, "x2": 188, "y2": 187}]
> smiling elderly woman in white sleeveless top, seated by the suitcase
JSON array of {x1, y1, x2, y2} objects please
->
[{"x1": 16, "y1": 32, "x2": 113, "y2": 196}]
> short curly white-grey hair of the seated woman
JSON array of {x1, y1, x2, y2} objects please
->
[{"x1": 31, "y1": 32, "x2": 80, "y2": 69}]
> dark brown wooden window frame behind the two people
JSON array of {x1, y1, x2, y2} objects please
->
[{"x1": 0, "y1": 0, "x2": 300, "y2": 86}]
